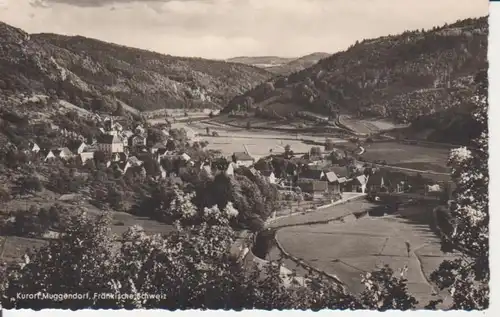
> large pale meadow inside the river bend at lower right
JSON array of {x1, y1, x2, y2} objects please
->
[{"x1": 276, "y1": 201, "x2": 458, "y2": 307}]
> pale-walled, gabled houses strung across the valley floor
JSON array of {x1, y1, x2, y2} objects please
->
[{"x1": 21, "y1": 118, "x2": 452, "y2": 204}]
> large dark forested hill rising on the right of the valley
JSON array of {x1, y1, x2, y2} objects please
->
[{"x1": 224, "y1": 17, "x2": 488, "y2": 123}]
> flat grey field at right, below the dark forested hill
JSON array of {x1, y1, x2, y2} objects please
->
[{"x1": 362, "y1": 142, "x2": 449, "y2": 173}]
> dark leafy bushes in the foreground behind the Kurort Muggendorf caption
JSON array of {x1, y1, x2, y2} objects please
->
[{"x1": 0, "y1": 188, "x2": 416, "y2": 309}]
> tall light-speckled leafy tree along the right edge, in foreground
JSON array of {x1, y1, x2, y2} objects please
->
[{"x1": 433, "y1": 72, "x2": 490, "y2": 310}]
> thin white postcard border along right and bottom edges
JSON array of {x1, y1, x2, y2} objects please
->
[{"x1": 3, "y1": 0, "x2": 500, "y2": 317}]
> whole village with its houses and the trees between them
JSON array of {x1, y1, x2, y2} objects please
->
[{"x1": 16, "y1": 109, "x2": 452, "y2": 213}]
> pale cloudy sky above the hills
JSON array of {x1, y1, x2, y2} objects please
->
[{"x1": 0, "y1": 0, "x2": 488, "y2": 59}]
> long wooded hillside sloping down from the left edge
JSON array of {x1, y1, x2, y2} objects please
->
[{"x1": 0, "y1": 22, "x2": 270, "y2": 111}]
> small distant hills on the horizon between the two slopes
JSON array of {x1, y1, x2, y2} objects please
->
[{"x1": 227, "y1": 53, "x2": 331, "y2": 75}]
